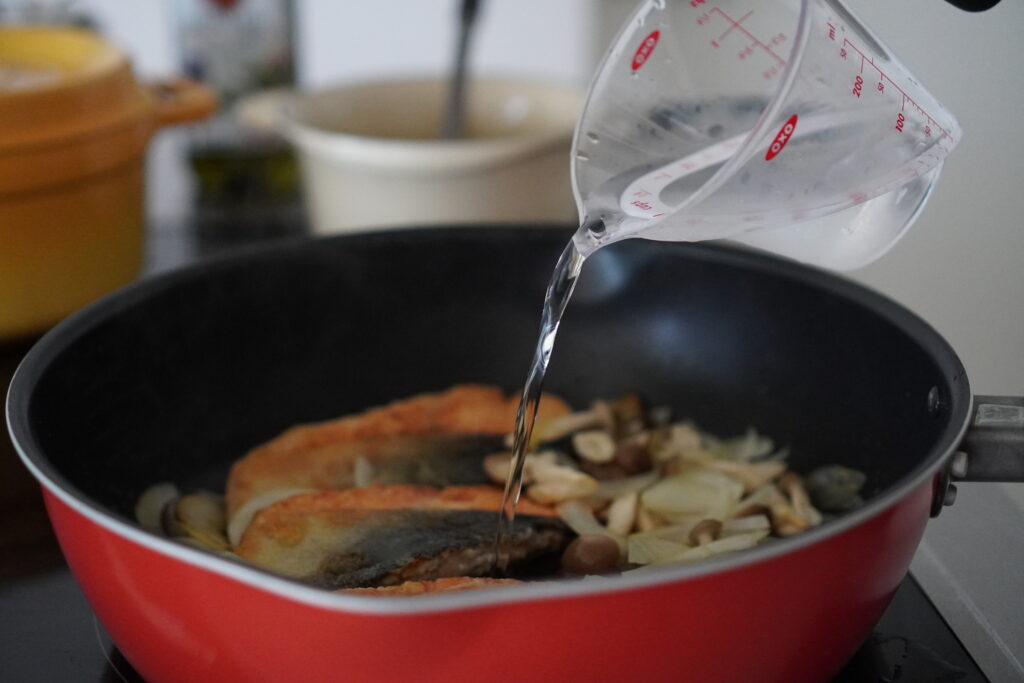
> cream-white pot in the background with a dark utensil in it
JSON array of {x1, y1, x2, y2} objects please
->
[{"x1": 284, "y1": 79, "x2": 583, "y2": 233}]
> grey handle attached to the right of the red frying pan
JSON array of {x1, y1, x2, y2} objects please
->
[{"x1": 949, "y1": 396, "x2": 1024, "y2": 481}]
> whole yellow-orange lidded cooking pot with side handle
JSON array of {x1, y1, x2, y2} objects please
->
[{"x1": 0, "y1": 27, "x2": 216, "y2": 339}]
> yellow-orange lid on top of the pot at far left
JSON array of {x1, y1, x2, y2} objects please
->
[{"x1": 0, "y1": 27, "x2": 148, "y2": 154}]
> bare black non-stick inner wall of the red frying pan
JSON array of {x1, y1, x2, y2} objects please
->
[{"x1": 11, "y1": 227, "x2": 970, "y2": 517}]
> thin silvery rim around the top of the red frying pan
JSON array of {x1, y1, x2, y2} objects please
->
[{"x1": 6, "y1": 225, "x2": 972, "y2": 615}]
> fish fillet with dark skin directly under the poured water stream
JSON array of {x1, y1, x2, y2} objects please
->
[{"x1": 234, "y1": 485, "x2": 573, "y2": 589}]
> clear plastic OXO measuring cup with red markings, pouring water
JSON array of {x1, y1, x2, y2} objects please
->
[{"x1": 572, "y1": 0, "x2": 961, "y2": 269}]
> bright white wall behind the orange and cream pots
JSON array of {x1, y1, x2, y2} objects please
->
[{"x1": 64, "y1": 0, "x2": 596, "y2": 86}]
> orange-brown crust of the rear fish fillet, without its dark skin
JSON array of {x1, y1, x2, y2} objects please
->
[{"x1": 226, "y1": 384, "x2": 569, "y2": 518}]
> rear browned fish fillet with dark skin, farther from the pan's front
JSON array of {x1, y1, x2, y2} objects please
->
[{"x1": 226, "y1": 385, "x2": 569, "y2": 518}]
